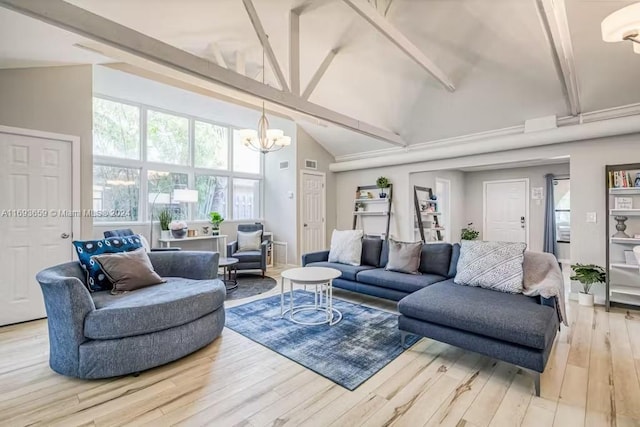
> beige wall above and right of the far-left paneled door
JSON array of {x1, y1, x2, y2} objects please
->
[{"x1": 0, "y1": 65, "x2": 93, "y2": 238}]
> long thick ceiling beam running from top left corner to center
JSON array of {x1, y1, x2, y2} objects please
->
[{"x1": 0, "y1": 0, "x2": 407, "y2": 146}]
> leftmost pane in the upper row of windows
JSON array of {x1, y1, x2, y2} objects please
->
[{"x1": 93, "y1": 98, "x2": 140, "y2": 159}]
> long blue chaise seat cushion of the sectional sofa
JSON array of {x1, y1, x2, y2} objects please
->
[{"x1": 398, "y1": 279, "x2": 558, "y2": 350}]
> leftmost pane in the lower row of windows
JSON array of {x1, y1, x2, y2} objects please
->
[{"x1": 93, "y1": 164, "x2": 140, "y2": 222}]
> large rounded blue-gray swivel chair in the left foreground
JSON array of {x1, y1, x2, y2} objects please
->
[{"x1": 36, "y1": 251, "x2": 226, "y2": 379}]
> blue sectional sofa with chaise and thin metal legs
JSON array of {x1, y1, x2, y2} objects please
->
[{"x1": 302, "y1": 239, "x2": 559, "y2": 396}]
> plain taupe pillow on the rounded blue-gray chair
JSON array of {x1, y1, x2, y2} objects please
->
[{"x1": 91, "y1": 248, "x2": 165, "y2": 293}]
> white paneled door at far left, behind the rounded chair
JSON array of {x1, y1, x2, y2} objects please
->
[{"x1": 0, "y1": 132, "x2": 73, "y2": 326}]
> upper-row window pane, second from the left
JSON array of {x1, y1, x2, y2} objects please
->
[{"x1": 147, "y1": 110, "x2": 189, "y2": 165}]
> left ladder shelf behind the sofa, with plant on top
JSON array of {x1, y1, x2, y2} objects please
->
[{"x1": 352, "y1": 184, "x2": 393, "y2": 240}]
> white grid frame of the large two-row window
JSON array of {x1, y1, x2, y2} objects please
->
[{"x1": 92, "y1": 93, "x2": 264, "y2": 226}]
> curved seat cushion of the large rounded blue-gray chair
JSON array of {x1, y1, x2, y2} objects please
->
[{"x1": 84, "y1": 277, "x2": 226, "y2": 339}]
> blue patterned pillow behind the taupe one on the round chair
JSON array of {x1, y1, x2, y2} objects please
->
[{"x1": 73, "y1": 235, "x2": 142, "y2": 292}]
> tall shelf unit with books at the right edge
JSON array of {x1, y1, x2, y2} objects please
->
[{"x1": 605, "y1": 163, "x2": 640, "y2": 310}]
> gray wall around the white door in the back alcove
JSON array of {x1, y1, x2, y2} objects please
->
[{"x1": 464, "y1": 164, "x2": 569, "y2": 259}]
